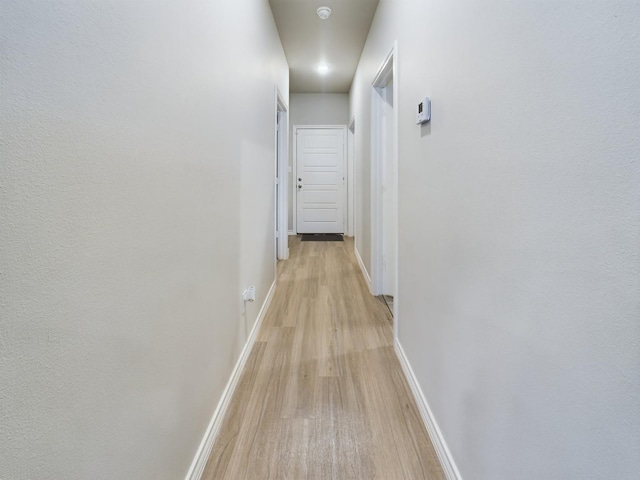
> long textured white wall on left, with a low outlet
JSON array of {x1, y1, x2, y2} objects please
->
[{"x1": 0, "y1": 0, "x2": 288, "y2": 480}]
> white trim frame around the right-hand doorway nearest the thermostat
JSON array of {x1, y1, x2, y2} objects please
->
[{"x1": 371, "y1": 41, "x2": 399, "y2": 338}]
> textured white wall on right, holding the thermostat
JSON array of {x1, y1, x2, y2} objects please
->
[{"x1": 351, "y1": 0, "x2": 640, "y2": 480}]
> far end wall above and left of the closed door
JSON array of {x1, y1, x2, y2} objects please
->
[{"x1": 289, "y1": 93, "x2": 349, "y2": 231}]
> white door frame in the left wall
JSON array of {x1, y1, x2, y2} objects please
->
[{"x1": 273, "y1": 87, "x2": 289, "y2": 263}]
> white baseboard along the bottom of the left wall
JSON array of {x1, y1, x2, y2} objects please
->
[{"x1": 185, "y1": 281, "x2": 276, "y2": 480}]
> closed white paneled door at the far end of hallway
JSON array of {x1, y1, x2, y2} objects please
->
[{"x1": 296, "y1": 128, "x2": 345, "y2": 233}]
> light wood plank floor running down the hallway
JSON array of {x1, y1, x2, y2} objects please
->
[{"x1": 203, "y1": 237, "x2": 445, "y2": 480}]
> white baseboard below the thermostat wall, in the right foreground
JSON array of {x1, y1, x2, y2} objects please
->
[{"x1": 394, "y1": 338, "x2": 462, "y2": 480}]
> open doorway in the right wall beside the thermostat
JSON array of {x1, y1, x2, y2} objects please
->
[{"x1": 371, "y1": 45, "x2": 398, "y2": 332}]
